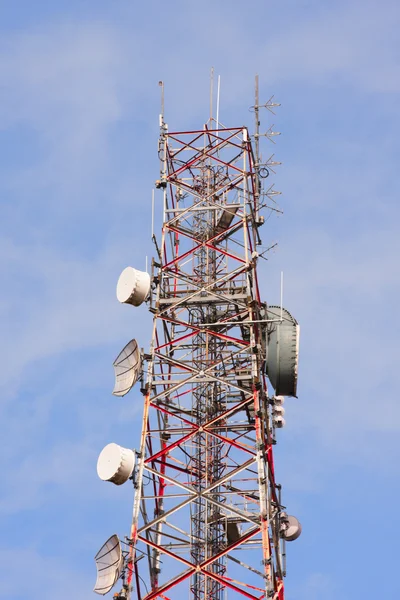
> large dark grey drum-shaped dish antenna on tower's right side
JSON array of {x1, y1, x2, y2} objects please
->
[{"x1": 266, "y1": 306, "x2": 300, "y2": 396}]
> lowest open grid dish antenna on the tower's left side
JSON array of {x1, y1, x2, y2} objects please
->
[{"x1": 93, "y1": 535, "x2": 124, "y2": 596}]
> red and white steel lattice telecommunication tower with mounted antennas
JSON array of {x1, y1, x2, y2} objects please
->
[{"x1": 94, "y1": 78, "x2": 301, "y2": 600}]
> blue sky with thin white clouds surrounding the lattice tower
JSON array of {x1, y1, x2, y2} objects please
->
[{"x1": 0, "y1": 0, "x2": 400, "y2": 600}]
